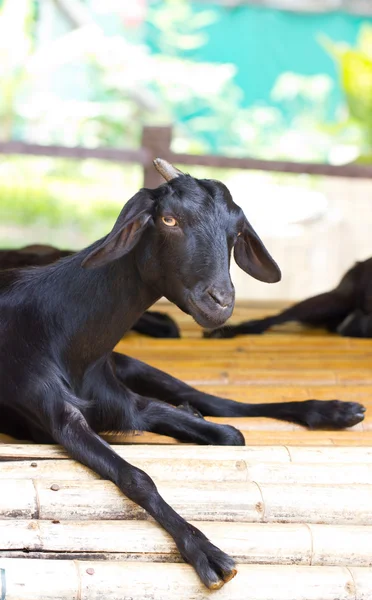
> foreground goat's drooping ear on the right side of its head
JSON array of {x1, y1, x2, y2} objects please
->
[{"x1": 234, "y1": 220, "x2": 282, "y2": 283}]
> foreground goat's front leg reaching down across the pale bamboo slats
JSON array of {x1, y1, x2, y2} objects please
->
[{"x1": 40, "y1": 401, "x2": 236, "y2": 589}]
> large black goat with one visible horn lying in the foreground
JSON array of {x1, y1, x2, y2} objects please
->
[{"x1": 0, "y1": 159, "x2": 364, "y2": 589}]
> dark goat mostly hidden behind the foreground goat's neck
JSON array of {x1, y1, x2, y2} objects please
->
[{"x1": 0, "y1": 244, "x2": 181, "y2": 338}]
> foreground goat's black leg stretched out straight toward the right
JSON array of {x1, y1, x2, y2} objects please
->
[{"x1": 112, "y1": 352, "x2": 365, "y2": 428}]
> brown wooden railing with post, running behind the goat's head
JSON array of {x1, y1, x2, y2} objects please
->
[{"x1": 0, "y1": 127, "x2": 372, "y2": 188}]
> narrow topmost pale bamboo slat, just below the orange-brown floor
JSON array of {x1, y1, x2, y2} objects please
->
[{"x1": 0, "y1": 444, "x2": 372, "y2": 464}]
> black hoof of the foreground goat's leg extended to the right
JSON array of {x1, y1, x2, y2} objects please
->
[{"x1": 304, "y1": 400, "x2": 366, "y2": 429}]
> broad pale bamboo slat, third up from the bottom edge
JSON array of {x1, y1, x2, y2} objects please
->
[{"x1": 0, "y1": 478, "x2": 372, "y2": 525}]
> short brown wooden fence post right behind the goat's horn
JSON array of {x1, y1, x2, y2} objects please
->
[{"x1": 142, "y1": 127, "x2": 172, "y2": 188}]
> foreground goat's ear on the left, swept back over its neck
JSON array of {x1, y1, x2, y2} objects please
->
[{"x1": 81, "y1": 189, "x2": 154, "y2": 269}]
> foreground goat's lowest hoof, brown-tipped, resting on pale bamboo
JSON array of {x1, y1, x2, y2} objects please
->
[{"x1": 181, "y1": 527, "x2": 237, "y2": 590}]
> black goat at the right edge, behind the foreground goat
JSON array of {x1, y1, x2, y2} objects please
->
[{"x1": 204, "y1": 258, "x2": 372, "y2": 338}]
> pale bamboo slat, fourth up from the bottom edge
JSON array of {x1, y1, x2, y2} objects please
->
[{"x1": 0, "y1": 458, "x2": 372, "y2": 485}]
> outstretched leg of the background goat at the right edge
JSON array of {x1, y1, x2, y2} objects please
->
[{"x1": 204, "y1": 290, "x2": 351, "y2": 338}]
